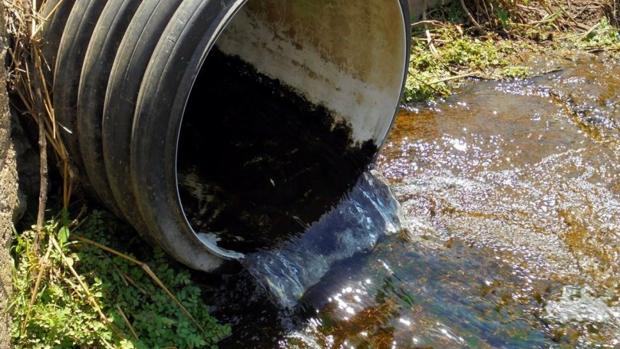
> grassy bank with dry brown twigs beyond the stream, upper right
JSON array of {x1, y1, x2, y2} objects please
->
[{"x1": 403, "y1": 0, "x2": 620, "y2": 103}]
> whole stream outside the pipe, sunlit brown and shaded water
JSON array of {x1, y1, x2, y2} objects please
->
[{"x1": 188, "y1": 55, "x2": 620, "y2": 348}]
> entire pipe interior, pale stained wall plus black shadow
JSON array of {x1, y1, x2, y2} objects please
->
[{"x1": 177, "y1": 0, "x2": 406, "y2": 252}]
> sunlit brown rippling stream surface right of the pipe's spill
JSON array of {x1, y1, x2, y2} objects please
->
[{"x1": 372, "y1": 53, "x2": 620, "y2": 347}]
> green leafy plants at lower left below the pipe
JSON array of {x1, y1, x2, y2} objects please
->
[{"x1": 12, "y1": 212, "x2": 230, "y2": 348}]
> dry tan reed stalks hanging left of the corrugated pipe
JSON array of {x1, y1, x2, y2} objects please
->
[{"x1": 2, "y1": 0, "x2": 87, "y2": 338}]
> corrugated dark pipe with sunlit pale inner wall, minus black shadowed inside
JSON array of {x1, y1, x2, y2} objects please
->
[{"x1": 44, "y1": 0, "x2": 410, "y2": 271}]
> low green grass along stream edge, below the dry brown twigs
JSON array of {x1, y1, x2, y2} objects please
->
[{"x1": 403, "y1": 2, "x2": 620, "y2": 103}]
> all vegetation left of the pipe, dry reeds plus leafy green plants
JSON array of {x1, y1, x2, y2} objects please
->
[{"x1": 4, "y1": 1, "x2": 230, "y2": 349}]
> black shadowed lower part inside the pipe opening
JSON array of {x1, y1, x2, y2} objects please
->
[{"x1": 178, "y1": 50, "x2": 377, "y2": 252}]
